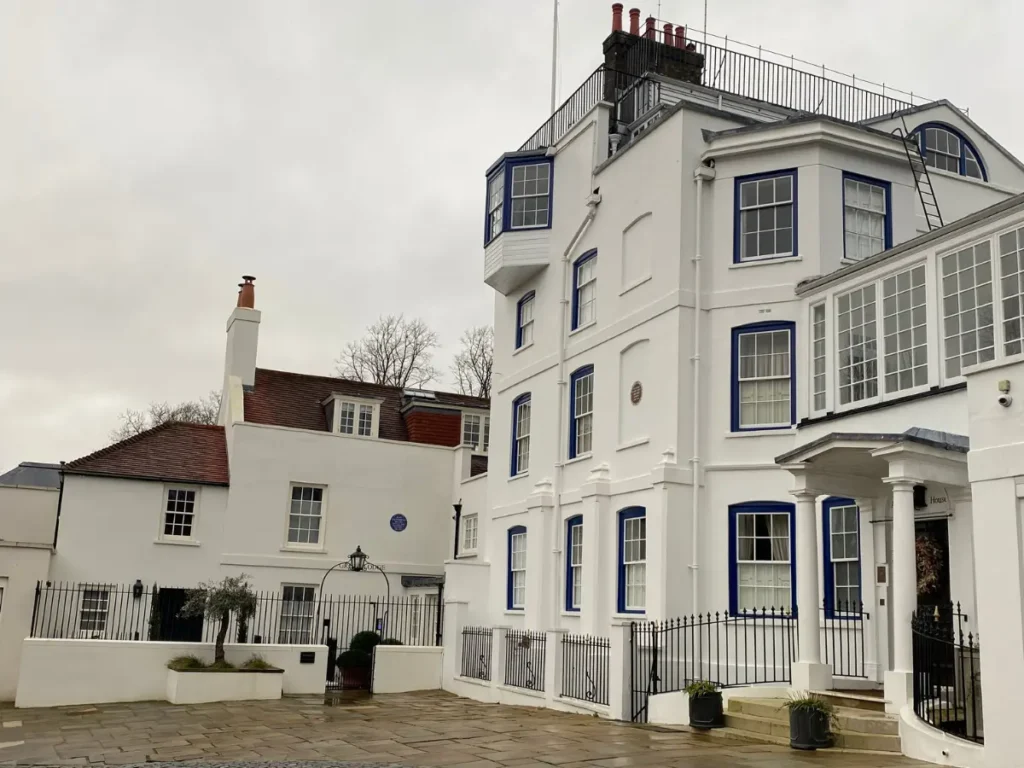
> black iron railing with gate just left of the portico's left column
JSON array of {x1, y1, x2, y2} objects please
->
[{"x1": 630, "y1": 608, "x2": 797, "y2": 722}]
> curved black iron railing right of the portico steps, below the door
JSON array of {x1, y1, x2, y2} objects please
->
[{"x1": 910, "y1": 604, "x2": 985, "y2": 743}]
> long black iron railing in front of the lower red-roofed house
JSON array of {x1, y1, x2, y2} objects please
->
[{"x1": 31, "y1": 583, "x2": 442, "y2": 648}]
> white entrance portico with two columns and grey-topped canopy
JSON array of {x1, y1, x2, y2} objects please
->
[{"x1": 775, "y1": 427, "x2": 973, "y2": 713}]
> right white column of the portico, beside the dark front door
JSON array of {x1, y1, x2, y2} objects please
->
[{"x1": 885, "y1": 477, "x2": 921, "y2": 713}]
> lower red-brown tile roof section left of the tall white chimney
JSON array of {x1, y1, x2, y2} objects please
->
[{"x1": 65, "y1": 422, "x2": 228, "y2": 485}]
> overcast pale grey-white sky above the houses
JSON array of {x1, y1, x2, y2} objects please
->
[{"x1": 0, "y1": 0, "x2": 1024, "y2": 471}]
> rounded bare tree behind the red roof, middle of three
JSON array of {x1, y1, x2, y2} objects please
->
[{"x1": 337, "y1": 314, "x2": 440, "y2": 387}]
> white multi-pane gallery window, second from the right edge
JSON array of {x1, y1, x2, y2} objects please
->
[{"x1": 935, "y1": 238, "x2": 1002, "y2": 382}]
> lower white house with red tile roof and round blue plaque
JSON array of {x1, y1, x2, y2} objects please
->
[{"x1": 0, "y1": 278, "x2": 489, "y2": 698}]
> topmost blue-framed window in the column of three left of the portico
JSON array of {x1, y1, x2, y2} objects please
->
[{"x1": 732, "y1": 168, "x2": 800, "y2": 263}]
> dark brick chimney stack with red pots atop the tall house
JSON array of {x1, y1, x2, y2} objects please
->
[{"x1": 604, "y1": 3, "x2": 705, "y2": 88}]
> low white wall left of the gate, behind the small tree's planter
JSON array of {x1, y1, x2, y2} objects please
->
[{"x1": 14, "y1": 638, "x2": 327, "y2": 707}]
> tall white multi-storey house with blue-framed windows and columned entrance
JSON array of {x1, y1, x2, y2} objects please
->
[{"x1": 447, "y1": 4, "x2": 1024, "y2": 765}]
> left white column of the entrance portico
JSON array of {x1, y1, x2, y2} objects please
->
[{"x1": 793, "y1": 490, "x2": 831, "y2": 690}]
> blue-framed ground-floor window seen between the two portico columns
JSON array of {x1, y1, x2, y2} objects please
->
[{"x1": 821, "y1": 497, "x2": 862, "y2": 618}]
